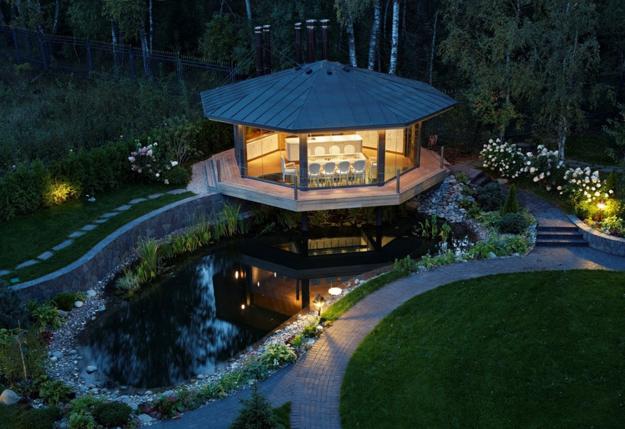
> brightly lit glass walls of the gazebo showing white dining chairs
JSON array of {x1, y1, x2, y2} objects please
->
[{"x1": 244, "y1": 123, "x2": 416, "y2": 188}]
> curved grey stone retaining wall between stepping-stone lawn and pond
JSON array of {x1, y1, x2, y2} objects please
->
[{"x1": 9, "y1": 194, "x2": 224, "y2": 300}]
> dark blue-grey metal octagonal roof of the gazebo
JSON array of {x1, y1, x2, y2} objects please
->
[{"x1": 200, "y1": 61, "x2": 456, "y2": 132}]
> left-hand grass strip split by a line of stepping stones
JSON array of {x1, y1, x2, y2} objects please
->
[{"x1": 0, "y1": 185, "x2": 191, "y2": 280}]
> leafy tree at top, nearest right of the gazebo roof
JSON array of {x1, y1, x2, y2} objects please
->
[{"x1": 441, "y1": 0, "x2": 538, "y2": 137}]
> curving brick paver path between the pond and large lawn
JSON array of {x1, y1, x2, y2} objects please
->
[{"x1": 153, "y1": 244, "x2": 625, "y2": 429}]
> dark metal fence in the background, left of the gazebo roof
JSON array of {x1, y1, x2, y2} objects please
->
[{"x1": 0, "y1": 26, "x2": 238, "y2": 86}]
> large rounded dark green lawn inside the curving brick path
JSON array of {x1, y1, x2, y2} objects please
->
[{"x1": 340, "y1": 271, "x2": 625, "y2": 428}]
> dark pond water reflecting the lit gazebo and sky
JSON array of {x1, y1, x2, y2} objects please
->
[{"x1": 79, "y1": 226, "x2": 464, "y2": 388}]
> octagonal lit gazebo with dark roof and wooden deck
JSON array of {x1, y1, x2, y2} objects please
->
[{"x1": 201, "y1": 60, "x2": 456, "y2": 211}]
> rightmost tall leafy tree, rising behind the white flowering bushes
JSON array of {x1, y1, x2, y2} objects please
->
[{"x1": 535, "y1": 0, "x2": 599, "y2": 159}]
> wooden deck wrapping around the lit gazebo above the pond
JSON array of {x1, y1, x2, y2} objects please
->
[{"x1": 206, "y1": 149, "x2": 449, "y2": 212}]
